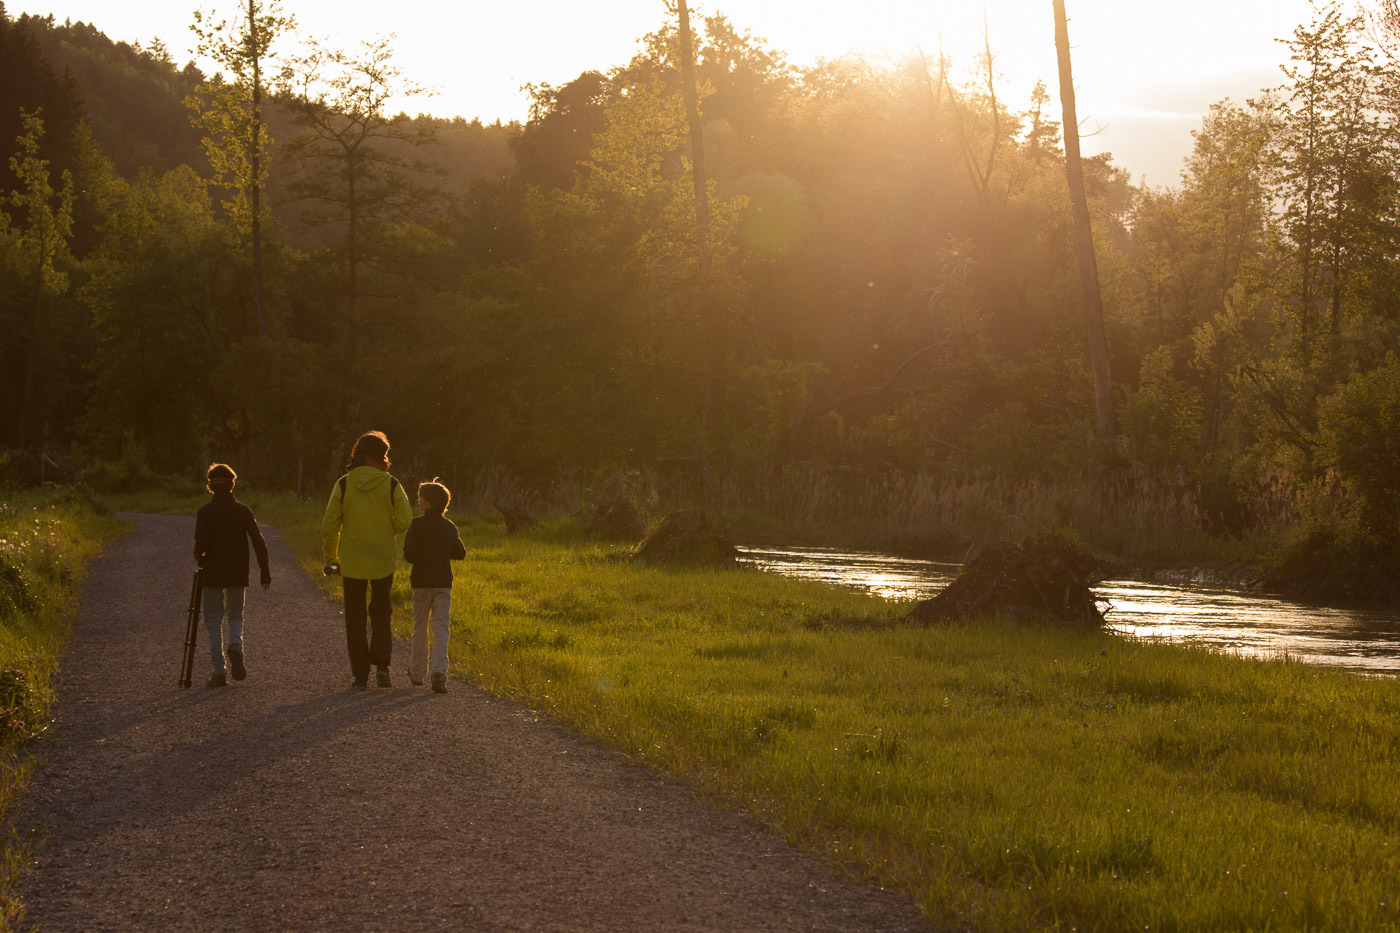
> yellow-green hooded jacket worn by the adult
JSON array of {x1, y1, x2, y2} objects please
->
[{"x1": 321, "y1": 467, "x2": 413, "y2": 580}]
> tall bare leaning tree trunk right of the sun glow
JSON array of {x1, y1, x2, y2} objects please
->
[{"x1": 1054, "y1": 0, "x2": 1117, "y2": 438}]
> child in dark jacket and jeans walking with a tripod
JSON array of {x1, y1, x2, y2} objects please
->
[{"x1": 195, "y1": 464, "x2": 272, "y2": 686}]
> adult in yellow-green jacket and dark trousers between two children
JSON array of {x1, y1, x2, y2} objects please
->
[{"x1": 321, "y1": 431, "x2": 413, "y2": 689}]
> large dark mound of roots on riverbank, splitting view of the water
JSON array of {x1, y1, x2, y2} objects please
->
[{"x1": 904, "y1": 538, "x2": 1105, "y2": 628}]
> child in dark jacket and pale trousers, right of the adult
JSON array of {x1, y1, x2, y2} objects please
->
[{"x1": 403, "y1": 478, "x2": 466, "y2": 693}]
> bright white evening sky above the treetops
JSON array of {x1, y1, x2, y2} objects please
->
[{"x1": 6, "y1": 0, "x2": 1312, "y2": 186}]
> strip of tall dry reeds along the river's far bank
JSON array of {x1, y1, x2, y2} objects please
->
[{"x1": 389, "y1": 465, "x2": 1276, "y2": 566}]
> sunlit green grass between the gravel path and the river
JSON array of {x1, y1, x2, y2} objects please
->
[{"x1": 259, "y1": 506, "x2": 1400, "y2": 930}]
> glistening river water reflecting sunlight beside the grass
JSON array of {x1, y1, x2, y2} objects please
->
[{"x1": 739, "y1": 548, "x2": 1400, "y2": 674}]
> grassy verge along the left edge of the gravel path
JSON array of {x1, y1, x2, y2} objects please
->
[{"x1": 0, "y1": 488, "x2": 122, "y2": 930}]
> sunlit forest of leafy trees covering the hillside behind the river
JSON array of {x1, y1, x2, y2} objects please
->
[{"x1": 0, "y1": 0, "x2": 1400, "y2": 602}]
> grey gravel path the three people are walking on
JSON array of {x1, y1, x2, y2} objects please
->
[{"x1": 10, "y1": 516, "x2": 928, "y2": 933}]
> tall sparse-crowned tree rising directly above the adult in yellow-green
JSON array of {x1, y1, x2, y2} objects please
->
[{"x1": 281, "y1": 35, "x2": 433, "y2": 373}]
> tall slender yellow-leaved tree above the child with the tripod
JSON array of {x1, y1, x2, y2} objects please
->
[{"x1": 186, "y1": 0, "x2": 297, "y2": 340}]
